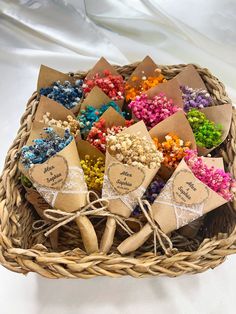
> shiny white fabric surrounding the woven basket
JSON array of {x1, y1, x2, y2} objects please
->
[{"x1": 0, "y1": 0, "x2": 236, "y2": 314}]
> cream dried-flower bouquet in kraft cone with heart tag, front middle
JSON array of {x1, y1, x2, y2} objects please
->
[{"x1": 100, "y1": 121, "x2": 162, "y2": 252}]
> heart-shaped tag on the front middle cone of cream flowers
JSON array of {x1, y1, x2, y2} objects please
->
[{"x1": 107, "y1": 163, "x2": 145, "y2": 195}]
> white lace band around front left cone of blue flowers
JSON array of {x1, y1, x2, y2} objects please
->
[{"x1": 34, "y1": 166, "x2": 88, "y2": 207}]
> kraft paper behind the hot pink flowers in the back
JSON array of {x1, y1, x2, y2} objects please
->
[{"x1": 143, "y1": 78, "x2": 184, "y2": 109}]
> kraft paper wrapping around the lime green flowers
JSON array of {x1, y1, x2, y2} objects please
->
[{"x1": 197, "y1": 104, "x2": 232, "y2": 156}]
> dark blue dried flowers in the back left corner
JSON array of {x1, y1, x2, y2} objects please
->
[{"x1": 40, "y1": 80, "x2": 83, "y2": 109}]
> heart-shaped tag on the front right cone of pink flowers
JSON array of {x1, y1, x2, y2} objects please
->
[{"x1": 172, "y1": 170, "x2": 209, "y2": 206}]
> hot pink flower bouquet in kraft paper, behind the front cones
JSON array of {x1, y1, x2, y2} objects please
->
[{"x1": 128, "y1": 79, "x2": 183, "y2": 129}]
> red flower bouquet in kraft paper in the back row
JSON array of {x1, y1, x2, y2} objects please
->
[{"x1": 83, "y1": 58, "x2": 124, "y2": 107}]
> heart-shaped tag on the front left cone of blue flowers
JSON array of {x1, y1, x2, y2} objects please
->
[{"x1": 29, "y1": 155, "x2": 68, "y2": 190}]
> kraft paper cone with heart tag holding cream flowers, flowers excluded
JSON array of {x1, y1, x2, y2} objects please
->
[{"x1": 100, "y1": 121, "x2": 161, "y2": 252}]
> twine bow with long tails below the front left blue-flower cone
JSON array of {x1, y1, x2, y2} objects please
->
[{"x1": 33, "y1": 191, "x2": 133, "y2": 237}]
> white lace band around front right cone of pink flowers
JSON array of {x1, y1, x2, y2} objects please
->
[{"x1": 154, "y1": 179, "x2": 204, "y2": 229}]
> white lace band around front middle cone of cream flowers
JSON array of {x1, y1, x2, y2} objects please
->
[{"x1": 102, "y1": 175, "x2": 145, "y2": 211}]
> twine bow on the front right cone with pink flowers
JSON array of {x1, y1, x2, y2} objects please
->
[{"x1": 138, "y1": 198, "x2": 173, "y2": 255}]
